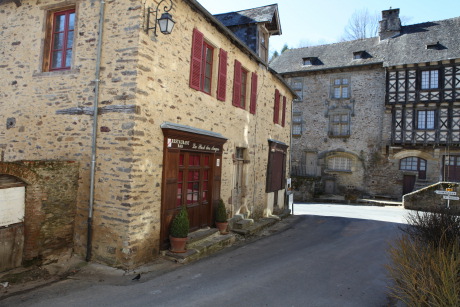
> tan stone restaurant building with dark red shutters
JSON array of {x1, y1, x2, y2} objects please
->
[{"x1": 0, "y1": 0, "x2": 295, "y2": 268}]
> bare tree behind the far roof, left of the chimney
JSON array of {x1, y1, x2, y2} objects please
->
[{"x1": 341, "y1": 8, "x2": 380, "y2": 41}]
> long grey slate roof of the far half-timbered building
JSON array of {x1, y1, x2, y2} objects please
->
[{"x1": 270, "y1": 17, "x2": 460, "y2": 73}]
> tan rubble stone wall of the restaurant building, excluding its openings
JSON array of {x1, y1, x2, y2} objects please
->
[{"x1": 0, "y1": 0, "x2": 292, "y2": 267}]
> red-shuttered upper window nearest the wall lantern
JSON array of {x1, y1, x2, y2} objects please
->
[{"x1": 190, "y1": 29, "x2": 227, "y2": 96}]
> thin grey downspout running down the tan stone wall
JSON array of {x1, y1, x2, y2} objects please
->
[{"x1": 86, "y1": 0, "x2": 105, "y2": 261}]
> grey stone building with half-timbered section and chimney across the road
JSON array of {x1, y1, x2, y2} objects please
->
[{"x1": 271, "y1": 9, "x2": 460, "y2": 201}]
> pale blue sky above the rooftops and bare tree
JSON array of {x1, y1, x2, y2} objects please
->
[{"x1": 198, "y1": 0, "x2": 460, "y2": 53}]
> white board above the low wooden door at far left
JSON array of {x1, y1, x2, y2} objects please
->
[{"x1": 0, "y1": 187, "x2": 26, "y2": 227}]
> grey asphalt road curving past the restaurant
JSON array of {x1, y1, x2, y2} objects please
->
[{"x1": 0, "y1": 207, "x2": 402, "y2": 307}]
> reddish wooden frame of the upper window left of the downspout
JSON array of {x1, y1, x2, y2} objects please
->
[{"x1": 41, "y1": 5, "x2": 77, "y2": 72}]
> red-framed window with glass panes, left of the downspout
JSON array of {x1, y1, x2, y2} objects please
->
[{"x1": 43, "y1": 8, "x2": 75, "y2": 71}]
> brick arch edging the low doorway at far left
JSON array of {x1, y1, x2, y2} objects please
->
[{"x1": 0, "y1": 161, "x2": 45, "y2": 260}]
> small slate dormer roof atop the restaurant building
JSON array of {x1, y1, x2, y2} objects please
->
[{"x1": 214, "y1": 4, "x2": 281, "y2": 35}]
